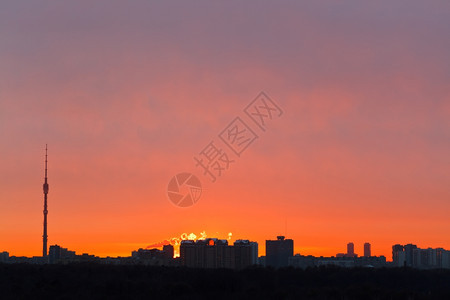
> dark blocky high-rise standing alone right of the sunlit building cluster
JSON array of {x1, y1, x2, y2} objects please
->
[{"x1": 266, "y1": 236, "x2": 294, "y2": 268}]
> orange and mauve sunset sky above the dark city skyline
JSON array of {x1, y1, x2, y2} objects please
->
[{"x1": 0, "y1": 0, "x2": 450, "y2": 260}]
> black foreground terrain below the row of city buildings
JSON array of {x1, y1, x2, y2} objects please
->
[{"x1": 0, "y1": 264, "x2": 450, "y2": 299}]
